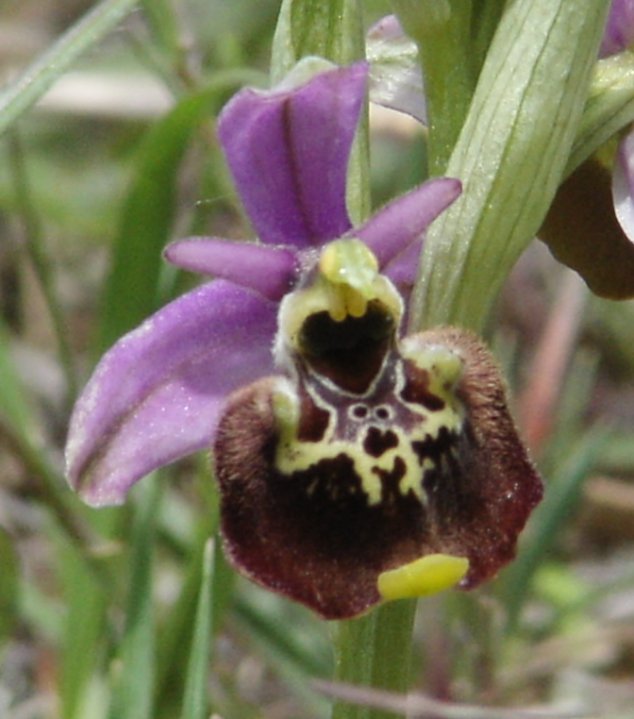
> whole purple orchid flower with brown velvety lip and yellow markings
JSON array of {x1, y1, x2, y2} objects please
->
[{"x1": 66, "y1": 63, "x2": 542, "y2": 618}]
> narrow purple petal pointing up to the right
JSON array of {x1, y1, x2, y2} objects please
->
[{"x1": 349, "y1": 177, "x2": 462, "y2": 268}]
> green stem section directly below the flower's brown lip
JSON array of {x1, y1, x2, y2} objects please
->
[{"x1": 332, "y1": 600, "x2": 416, "y2": 719}]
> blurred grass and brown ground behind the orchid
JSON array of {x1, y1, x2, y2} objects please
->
[{"x1": 0, "y1": 0, "x2": 634, "y2": 719}]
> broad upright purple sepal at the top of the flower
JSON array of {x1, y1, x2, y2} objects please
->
[{"x1": 218, "y1": 63, "x2": 367, "y2": 248}]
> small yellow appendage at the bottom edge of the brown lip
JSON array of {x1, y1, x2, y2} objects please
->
[{"x1": 377, "y1": 554, "x2": 469, "y2": 600}]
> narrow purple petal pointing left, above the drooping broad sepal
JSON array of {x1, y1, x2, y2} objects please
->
[{"x1": 164, "y1": 237, "x2": 297, "y2": 301}]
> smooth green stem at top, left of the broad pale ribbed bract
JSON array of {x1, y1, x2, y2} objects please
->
[{"x1": 393, "y1": 0, "x2": 475, "y2": 175}]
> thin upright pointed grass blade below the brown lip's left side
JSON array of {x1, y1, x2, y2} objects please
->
[{"x1": 181, "y1": 539, "x2": 218, "y2": 719}]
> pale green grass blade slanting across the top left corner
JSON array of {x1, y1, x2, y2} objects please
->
[{"x1": 0, "y1": 0, "x2": 138, "y2": 135}]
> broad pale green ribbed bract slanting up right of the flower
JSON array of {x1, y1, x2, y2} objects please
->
[{"x1": 411, "y1": 0, "x2": 609, "y2": 330}]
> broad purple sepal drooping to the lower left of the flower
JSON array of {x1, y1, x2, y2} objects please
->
[{"x1": 66, "y1": 280, "x2": 276, "y2": 506}]
